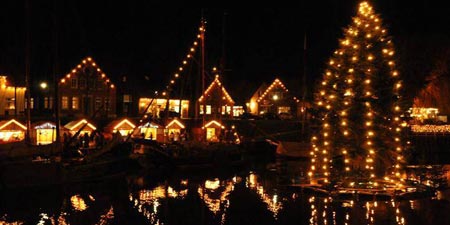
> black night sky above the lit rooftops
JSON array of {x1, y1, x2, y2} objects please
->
[{"x1": 0, "y1": 0, "x2": 450, "y2": 100}]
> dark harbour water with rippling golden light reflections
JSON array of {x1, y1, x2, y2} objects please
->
[{"x1": 0, "y1": 161, "x2": 450, "y2": 225}]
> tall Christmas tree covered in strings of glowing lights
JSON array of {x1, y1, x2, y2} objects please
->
[{"x1": 309, "y1": 2, "x2": 403, "y2": 186}]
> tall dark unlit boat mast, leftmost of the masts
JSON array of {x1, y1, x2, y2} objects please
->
[{"x1": 25, "y1": 0, "x2": 31, "y2": 143}]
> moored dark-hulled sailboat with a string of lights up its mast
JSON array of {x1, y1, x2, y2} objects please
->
[{"x1": 133, "y1": 18, "x2": 244, "y2": 169}]
